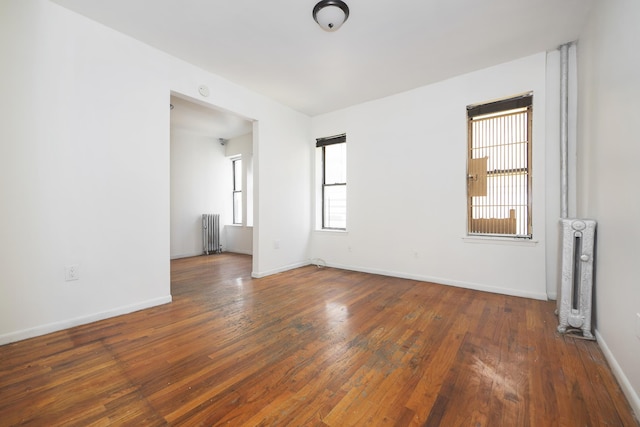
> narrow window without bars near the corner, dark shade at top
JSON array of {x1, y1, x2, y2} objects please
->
[{"x1": 316, "y1": 134, "x2": 347, "y2": 230}]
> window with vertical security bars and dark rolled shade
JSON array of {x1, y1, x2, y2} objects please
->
[{"x1": 467, "y1": 94, "x2": 532, "y2": 238}]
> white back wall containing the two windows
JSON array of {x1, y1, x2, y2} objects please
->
[{"x1": 309, "y1": 53, "x2": 559, "y2": 299}]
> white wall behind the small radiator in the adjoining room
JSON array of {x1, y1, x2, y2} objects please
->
[{"x1": 171, "y1": 129, "x2": 233, "y2": 258}]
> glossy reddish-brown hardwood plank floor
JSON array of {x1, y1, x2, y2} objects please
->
[{"x1": 0, "y1": 254, "x2": 638, "y2": 426}]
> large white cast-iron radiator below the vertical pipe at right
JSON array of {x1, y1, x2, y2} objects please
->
[{"x1": 558, "y1": 219, "x2": 596, "y2": 339}]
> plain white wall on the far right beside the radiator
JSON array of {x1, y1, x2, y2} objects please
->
[{"x1": 578, "y1": 0, "x2": 640, "y2": 416}]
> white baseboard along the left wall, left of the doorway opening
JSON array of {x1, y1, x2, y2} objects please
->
[{"x1": 0, "y1": 295, "x2": 171, "y2": 345}]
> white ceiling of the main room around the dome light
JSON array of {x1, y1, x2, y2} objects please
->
[{"x1": 53, "y1": 0, "x2": 595, "y2": 116}]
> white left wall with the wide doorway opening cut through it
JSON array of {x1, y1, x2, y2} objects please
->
[{"x1": 0, "y1": 0, "x2": 311, "y2": 343}]
